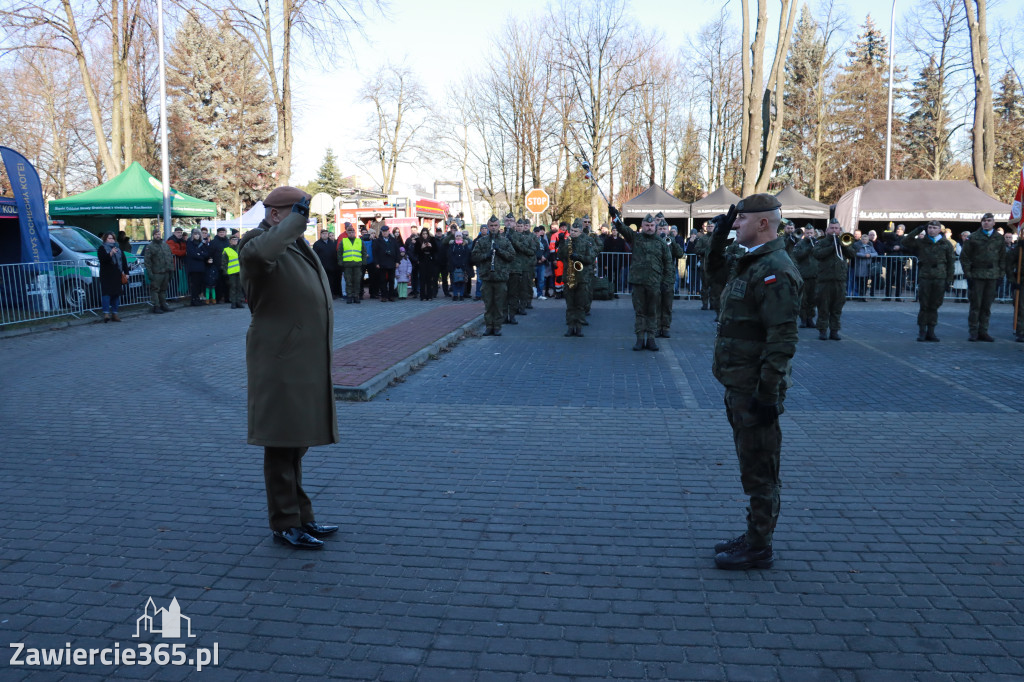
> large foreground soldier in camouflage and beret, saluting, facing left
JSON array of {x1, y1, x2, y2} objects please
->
[{"x1": 711, "y1": 195, "x2": 803, "y2": 569}]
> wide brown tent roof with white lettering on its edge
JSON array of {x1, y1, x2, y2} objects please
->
[{"x1": 836, "y1": 180, "x2": 1010, "y2": 231}]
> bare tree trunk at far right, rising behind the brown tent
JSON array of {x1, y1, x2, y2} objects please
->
[{"x1": 964, "y1": 0, "x2": 995, "y2": 195}]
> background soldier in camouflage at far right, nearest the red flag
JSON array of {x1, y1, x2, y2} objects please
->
[{"x1": 961, "y1": 213, "x2": 1007, "y2": 341}]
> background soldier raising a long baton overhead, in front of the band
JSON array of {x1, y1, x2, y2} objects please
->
[{"x1": 608, "y1": 205, "x2": 672, "y2": 350}]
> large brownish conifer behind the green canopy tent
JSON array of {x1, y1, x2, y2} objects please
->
[{"x1": 168, "y1": 15, "x2": 276, "y2": 212}]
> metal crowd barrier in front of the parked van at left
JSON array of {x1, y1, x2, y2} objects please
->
[{"x1": 0, "y1": 258, "x2": 188, "y2": 327}]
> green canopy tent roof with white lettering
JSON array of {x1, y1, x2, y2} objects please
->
[{"x1": 49, "y1": 161, "x2": 217, "y2": 218}]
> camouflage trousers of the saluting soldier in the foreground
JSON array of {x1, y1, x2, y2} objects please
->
[{"x1": 725, "y1": 388, "x2": 782, "y2": 547}]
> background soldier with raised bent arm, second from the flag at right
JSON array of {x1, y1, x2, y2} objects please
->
[{"x1": 900, "y1": 220, "x2": 955, "y2": 341}]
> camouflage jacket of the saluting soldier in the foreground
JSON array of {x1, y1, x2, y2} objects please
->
[{"x1": 712, "y1": 239, "x2": 804, "y2": 404}]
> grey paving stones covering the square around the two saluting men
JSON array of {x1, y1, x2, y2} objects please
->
[{"x1": 0, "y1": 298, "x2": 1024, "y2": 682}]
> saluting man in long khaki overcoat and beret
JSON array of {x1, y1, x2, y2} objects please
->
[{"x1": 239, "y1": 186, "x2": 338, "y2": 549}]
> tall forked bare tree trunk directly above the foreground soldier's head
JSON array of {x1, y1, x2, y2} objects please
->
[{"x1": 741, "y1": 0, "x2": 797, "y2": 196}]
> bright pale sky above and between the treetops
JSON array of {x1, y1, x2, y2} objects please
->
[{"x1": 282, "y1": 0, "x2": 1016, "y2": 192}]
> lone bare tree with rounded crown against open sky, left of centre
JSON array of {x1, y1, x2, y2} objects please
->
[{"x1": 362, "y1": 65, "x2": 428, "y2": 195}]
